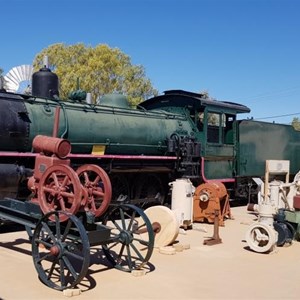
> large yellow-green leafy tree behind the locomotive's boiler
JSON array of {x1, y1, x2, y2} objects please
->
[{"x1": 34, "y1": 43, "x2": 158, "y2": 105}]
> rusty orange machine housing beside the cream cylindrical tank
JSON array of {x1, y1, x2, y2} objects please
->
[{"x1": 193, "y1": 181, "x2": 231, "y2": 226}]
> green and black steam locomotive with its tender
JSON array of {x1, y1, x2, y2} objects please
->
[{"x1": 0, "y1": 67, "x2": 300, "y2": 204}]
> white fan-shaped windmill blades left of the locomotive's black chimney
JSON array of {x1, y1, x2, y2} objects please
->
[{"x1": 4, "y1": 65, "x2": 33, "y2": 94}]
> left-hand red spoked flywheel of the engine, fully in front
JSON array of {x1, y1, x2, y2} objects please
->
[{"x1": 38, "y1": 165, "x2": 82, "y2": 222}]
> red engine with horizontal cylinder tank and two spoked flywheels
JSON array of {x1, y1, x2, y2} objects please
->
[{"x1": 28, "y1": 135, "x2": 112, "y2": 222}]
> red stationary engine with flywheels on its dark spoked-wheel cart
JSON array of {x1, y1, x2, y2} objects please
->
[{"x1": 0, "y1": 135, "x2": 154, "y2": 290}]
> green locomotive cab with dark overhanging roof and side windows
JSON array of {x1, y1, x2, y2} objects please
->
[{"x1": 140, "y1": 90, "x2": 250, "y2": 182}]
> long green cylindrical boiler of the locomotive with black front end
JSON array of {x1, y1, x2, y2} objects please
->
[{"x1": 0, "y1": 81, "x2": 192, "y2": 155}]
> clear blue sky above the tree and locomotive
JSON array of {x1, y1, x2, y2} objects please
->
[{"x1": 0, "y1": 0, "x2": 300, "y2": 123}]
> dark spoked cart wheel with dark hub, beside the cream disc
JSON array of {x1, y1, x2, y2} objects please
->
[{"x1": 103, "y1": 204, "x2": 154, "y2": 272}]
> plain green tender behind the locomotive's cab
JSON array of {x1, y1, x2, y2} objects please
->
[{"x1": 238, "y1": 120, "x2": 300, "y2": 177}]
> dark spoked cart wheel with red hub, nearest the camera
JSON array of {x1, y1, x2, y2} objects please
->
[{"x1": 32, "y1": 211, "x2": 90, "y2": 290}]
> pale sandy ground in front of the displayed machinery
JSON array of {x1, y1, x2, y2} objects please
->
[{"x1": 0, "y1": 207, "x2": 300, "y2": 300}]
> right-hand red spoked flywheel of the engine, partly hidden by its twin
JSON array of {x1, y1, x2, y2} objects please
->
[{"x1": 76, "y1": 165, "x2": 112, "y2": 217}]
